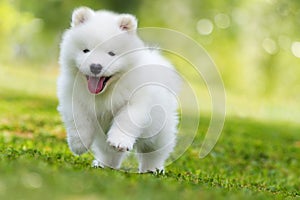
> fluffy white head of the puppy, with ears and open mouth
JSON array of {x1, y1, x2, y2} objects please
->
[{"x1": 60, "y1": 7, "x2": 142, "y2": 94}]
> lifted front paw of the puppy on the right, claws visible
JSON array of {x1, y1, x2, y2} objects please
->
[{"x1": 107, "y1": 133, "x2": 135, "y2": 152}]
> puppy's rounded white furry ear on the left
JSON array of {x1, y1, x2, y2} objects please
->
[{"x1": 71, "y1": 7, "x2": 94, "y2": 27}]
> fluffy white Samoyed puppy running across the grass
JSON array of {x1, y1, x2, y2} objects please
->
[{"x1": 57, "y1": 7, "x2": 181, "y2": 173}]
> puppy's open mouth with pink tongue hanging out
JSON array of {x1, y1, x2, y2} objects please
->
[{"x1": 86, "y1": 76, "x2": 111, "y2": 94}]
